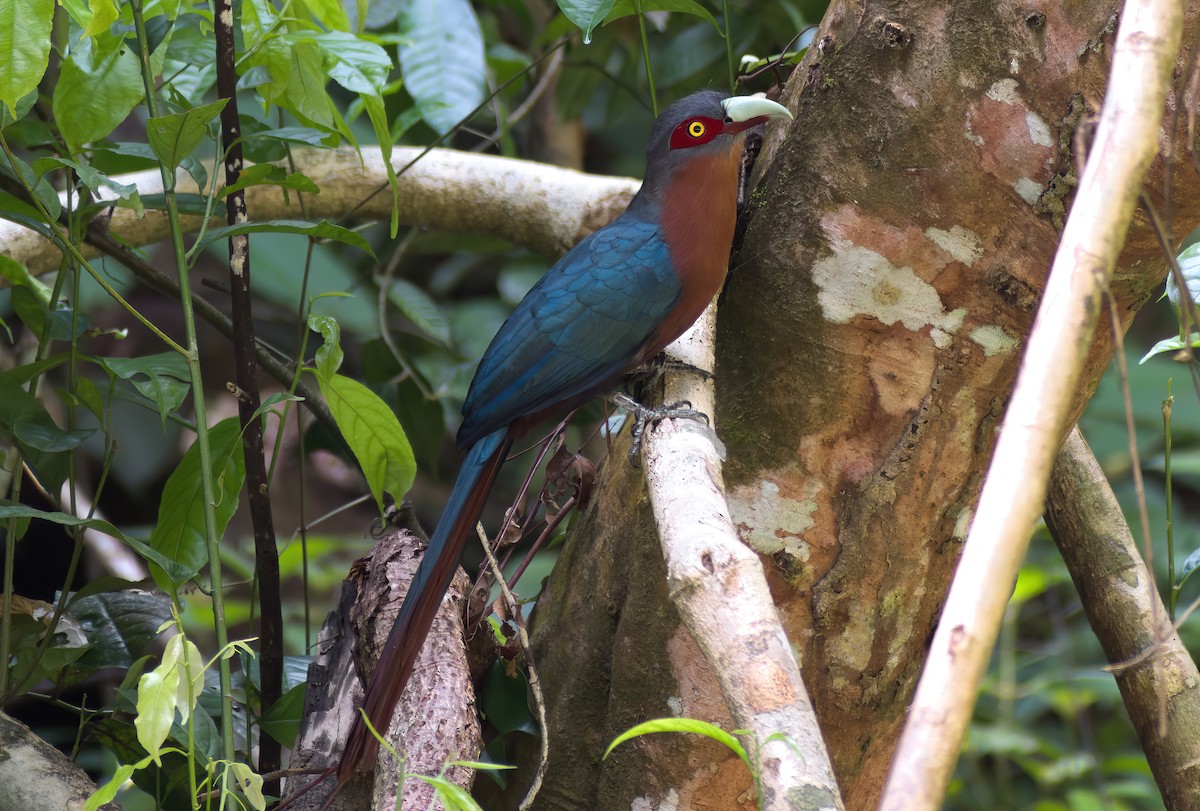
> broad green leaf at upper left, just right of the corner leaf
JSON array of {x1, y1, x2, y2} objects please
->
[{"x1": 52, "y1": 38, "x2": 144, "y2": 152}]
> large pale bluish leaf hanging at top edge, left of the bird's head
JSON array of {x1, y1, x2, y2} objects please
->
[{"x1": 400, "y1": 0, "x2": 486, "y2": 134}]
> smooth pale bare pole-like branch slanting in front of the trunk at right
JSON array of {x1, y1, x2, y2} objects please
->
[{"x1": 880, "y1": 0, "x2": 1183, "y2": 811}]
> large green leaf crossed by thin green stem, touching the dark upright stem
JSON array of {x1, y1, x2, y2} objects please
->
[{"x1": 150, "y1": 416, "x2": 246, "y2": 594}]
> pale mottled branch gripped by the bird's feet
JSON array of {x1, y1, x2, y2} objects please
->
[{"x1": 644, "y1": 305, "x2": 844, "y2": 810}]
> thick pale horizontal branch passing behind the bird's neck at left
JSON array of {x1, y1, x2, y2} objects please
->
[{"x1": 0, "y1": 146, "x2": 638, "y2": 280}]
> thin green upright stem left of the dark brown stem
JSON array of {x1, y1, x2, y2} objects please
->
[{"x1": 130, "y1": 0, "x2": 236, "y2": 777}]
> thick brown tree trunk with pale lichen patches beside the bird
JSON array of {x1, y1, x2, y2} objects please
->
[{"x1": 511, "y1": 0, "x2": 1200, "y2": 809}]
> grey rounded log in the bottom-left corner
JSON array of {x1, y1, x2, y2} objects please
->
[{"x1": 0, "y1": 713, "x2": 121, "y2": 811}]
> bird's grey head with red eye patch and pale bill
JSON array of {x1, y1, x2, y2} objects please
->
[{"x1": 646, "y1": 90, "x2": 792, "y2": 193}]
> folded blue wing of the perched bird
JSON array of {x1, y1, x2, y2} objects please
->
[{"x1": 458, "y1": 214, "x2": 680, "y2": 447}]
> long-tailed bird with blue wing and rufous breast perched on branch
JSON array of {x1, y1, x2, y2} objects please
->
[{"x1": 337, "y1": 90, "x2": 792, "y2": 787}]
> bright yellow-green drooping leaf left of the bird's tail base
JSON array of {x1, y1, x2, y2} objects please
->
[{"x1": 317, "y1": 374, "x2": 416, "y2": 513}]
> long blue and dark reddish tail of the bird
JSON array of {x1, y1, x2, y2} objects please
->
[{"x1": 337, "y1": 428, "x2": 512, "y2": 786}]
